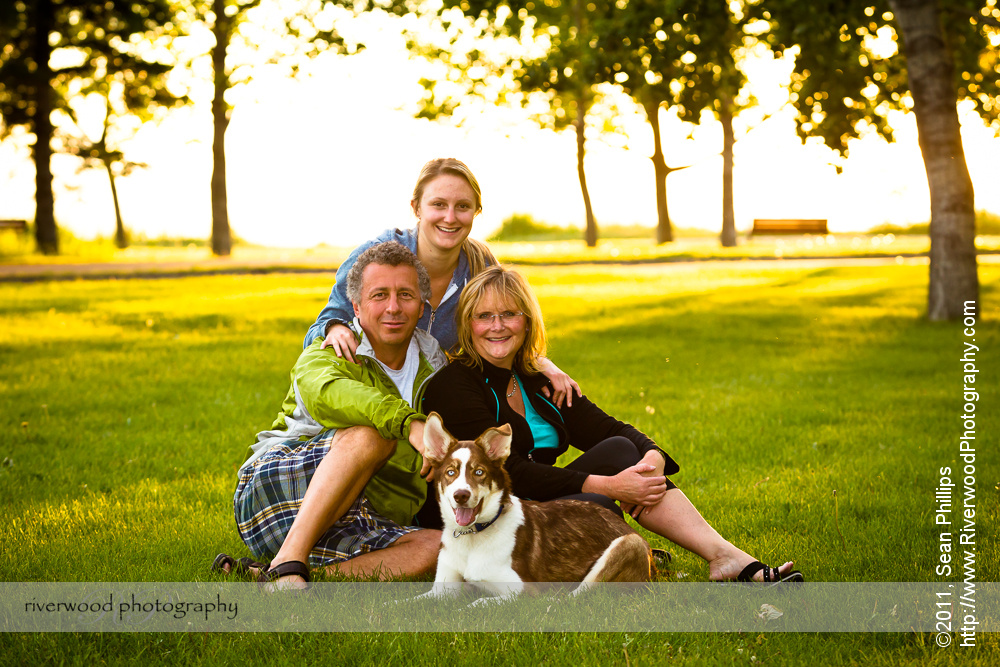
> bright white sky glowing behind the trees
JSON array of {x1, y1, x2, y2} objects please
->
[{"x1": 0, "y1": 7, "x2": 1000, "y2": 247}]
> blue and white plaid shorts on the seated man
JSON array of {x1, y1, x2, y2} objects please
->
[{"x1": 233, "y1": 429, "x2": 418, "y2": 567}]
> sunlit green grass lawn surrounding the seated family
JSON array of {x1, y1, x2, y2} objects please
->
[{"x1": 0, "y1": 263, "x2": 1000, "y2": 665}]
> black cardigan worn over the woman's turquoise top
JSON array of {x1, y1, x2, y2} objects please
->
[{"x1": 420, "y1": 361, "x2": 679, "y2": 500}]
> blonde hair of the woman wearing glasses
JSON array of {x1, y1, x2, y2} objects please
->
[{"x1": 452, "y1": 265, "x2": 546, "y2": 375}]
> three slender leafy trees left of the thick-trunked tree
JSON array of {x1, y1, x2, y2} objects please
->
[{"x1": 414, "y1": 0, "x2": 753, "y2": 243}]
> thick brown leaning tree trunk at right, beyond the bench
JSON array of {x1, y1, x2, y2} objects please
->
[{"x1": 889, "y1": 0, "x2": 979, "y2": 320}]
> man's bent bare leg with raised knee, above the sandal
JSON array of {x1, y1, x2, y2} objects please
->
[{"x1": 271, "y1": 426, "x2": 396, "y2": 583}]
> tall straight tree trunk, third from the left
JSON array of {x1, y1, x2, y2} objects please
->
[{"x1": 212, "y1": 0, "x2": 232, "y2": 255}]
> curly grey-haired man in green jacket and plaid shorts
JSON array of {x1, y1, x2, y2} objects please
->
[{"x1": 233, "y1": 241, "x2": 447, "y2": 586}]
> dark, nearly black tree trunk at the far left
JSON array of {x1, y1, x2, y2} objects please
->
[{"x1": 32, "y1": 0, "x2": 59, "y2": 255}]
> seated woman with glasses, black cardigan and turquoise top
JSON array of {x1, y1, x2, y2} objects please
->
[{"x1": 418, "y1": 266, "x2": 802, "y2": 582}]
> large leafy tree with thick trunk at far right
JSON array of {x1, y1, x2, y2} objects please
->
[{"x1": 764, "y1": 0, "x2": 1000, "y2": 320}]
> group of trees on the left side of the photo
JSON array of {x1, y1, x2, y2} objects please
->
[{"x1": 0, "y1": 0, "x2": 360, "y2": 255}]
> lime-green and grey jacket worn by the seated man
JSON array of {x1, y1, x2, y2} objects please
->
[{"x1": 242, "y1": 323, "x2": 448, "y2": 526}]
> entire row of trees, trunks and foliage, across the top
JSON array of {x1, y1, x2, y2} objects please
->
[{"x1": 0, "y1": 0, "x2": 1000, "y2": 319}]
